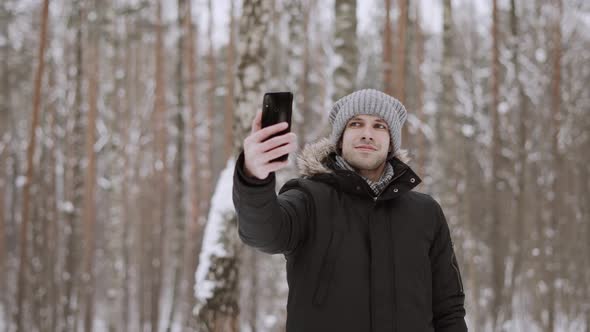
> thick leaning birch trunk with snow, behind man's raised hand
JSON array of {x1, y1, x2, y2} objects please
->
[{"x1": 195, "y1": 0, "x2": 271, "y2": 331}]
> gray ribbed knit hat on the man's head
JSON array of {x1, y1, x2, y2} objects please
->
[{"x1": 329, "y1": 89, "x2": 408, "y2": 158}]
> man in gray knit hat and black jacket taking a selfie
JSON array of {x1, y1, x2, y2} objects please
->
[{"x1": 233, "y1": 89, "x2": 467, "y2": 332}]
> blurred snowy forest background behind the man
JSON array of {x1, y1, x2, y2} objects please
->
[{"x1": 0, "y1": 0, "x2": 590, "y2": 332}]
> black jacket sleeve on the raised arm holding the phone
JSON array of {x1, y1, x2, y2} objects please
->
[{"x1": 232, "y1": 152, "x2": 312, "y2": 255}]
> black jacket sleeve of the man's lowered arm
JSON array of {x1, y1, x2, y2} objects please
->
[{"x1": 429, "y1": 203, "x2": 467, "y2": 332}]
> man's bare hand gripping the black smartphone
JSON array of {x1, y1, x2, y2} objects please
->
[{"x1": 244, "y1": 111, "x2": 297, "y2": 180}]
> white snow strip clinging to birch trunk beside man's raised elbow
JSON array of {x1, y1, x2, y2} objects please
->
[{"x1": 194, "y1": 158, "x2": 235, "y2": 303}]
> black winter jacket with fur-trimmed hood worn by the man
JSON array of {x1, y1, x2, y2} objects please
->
[{"x1": 233, "y1": 139, "x2": 467, "y2": 332}]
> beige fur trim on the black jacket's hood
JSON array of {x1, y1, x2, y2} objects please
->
[{"x1": 297, "y1": 138, "x2": 410, "y2": 176}]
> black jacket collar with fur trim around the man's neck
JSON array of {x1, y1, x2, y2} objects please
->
[{"x1": 297, "y1": 138, "x2": 422, "y2": 200}]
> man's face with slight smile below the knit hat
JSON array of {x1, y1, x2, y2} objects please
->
[{"x1": 340, "y1": 114, "x2": 390, "y2": 171}]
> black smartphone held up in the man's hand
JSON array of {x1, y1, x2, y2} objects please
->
[{"x1": 261, "y1": 92, "x2": 293, "y2": 162}]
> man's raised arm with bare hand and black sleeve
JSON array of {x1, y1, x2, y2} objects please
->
[{"x1": 232, "y1": 111, "x2": 311, "y2": 254}]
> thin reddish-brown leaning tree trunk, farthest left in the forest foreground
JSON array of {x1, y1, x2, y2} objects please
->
[{"x1": 14, "y1": 0, "x2": 49, "y2": 332}]
